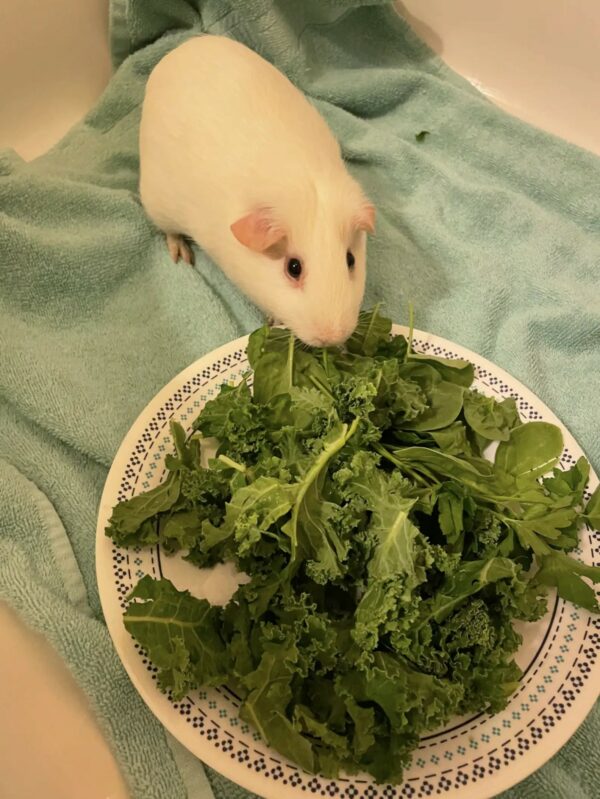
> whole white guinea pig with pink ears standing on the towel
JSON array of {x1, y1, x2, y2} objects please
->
[{"x1": 140, "y1": 36, "x2": 375, "y2": 346}]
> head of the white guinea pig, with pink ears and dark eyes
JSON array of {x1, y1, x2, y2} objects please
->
[{"x1": 231, "y1": 182, "x2": 375, "y2": 347}]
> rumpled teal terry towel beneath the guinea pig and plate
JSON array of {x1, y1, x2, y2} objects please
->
[{"x1": 0, "y1": 0, "x2": 600, "y2": 799}]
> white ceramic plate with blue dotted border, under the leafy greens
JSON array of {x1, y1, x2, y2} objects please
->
[{"x1": 96, "y1": 327, "x2": 600, "y2": 799}]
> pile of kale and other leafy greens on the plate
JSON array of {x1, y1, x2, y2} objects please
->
[{"x1": 107, "y1": 310, "x2": 600, "y2": 782}]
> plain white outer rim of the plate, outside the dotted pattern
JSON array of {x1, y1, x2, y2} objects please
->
[{"x1": 94, "y1": 324, "x2": 600, "y2": 799}]
